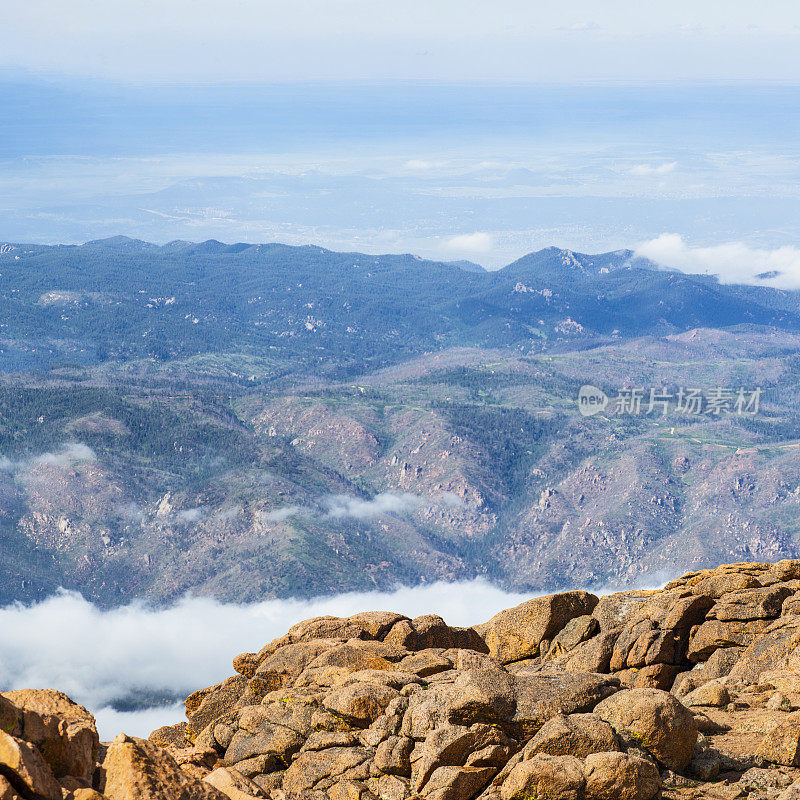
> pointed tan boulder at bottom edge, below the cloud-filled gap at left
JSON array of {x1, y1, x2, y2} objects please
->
[{"x1": 99, "y1": 734, "x2": 228, "y2": 800}]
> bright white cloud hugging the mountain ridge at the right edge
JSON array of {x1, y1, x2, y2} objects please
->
[{"x1": 636, "y1": 234, "x2": 800, "y2": 289}]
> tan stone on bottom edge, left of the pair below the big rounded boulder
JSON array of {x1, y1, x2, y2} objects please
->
[{"x1": 500, "y1": 754, "x2": 586, "y2": 800}]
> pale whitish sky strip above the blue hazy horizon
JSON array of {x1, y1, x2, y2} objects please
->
[{"x1": 0, "y1": 0, "x2": 800, "y2": 82}]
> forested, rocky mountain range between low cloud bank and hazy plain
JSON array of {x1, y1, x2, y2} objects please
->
[{"x1": 0, "y1": 237, "x2": 800, "y2": 605}]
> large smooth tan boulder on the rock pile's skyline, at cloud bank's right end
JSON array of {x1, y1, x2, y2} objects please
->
[{"x1": 475, "y1": 592, "x2": 598, "y2": 664}]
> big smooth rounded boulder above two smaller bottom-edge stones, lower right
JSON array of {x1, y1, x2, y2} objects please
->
[{"x1": 594, "y1": 689, "x2": 697, "y2": 772}]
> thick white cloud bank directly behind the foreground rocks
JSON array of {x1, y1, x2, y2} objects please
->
[{"x1": 0, "y1": 580, "x2": 532, "y2": 738}]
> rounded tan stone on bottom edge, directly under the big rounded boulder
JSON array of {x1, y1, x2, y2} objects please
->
[{"x1": 583, "y1": 753, "x2": 661, "y2": 800}]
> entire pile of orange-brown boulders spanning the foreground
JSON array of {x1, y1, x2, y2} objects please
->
[{"x1": 7, "y1": 561, "x2": 800, "y2": 800}]
